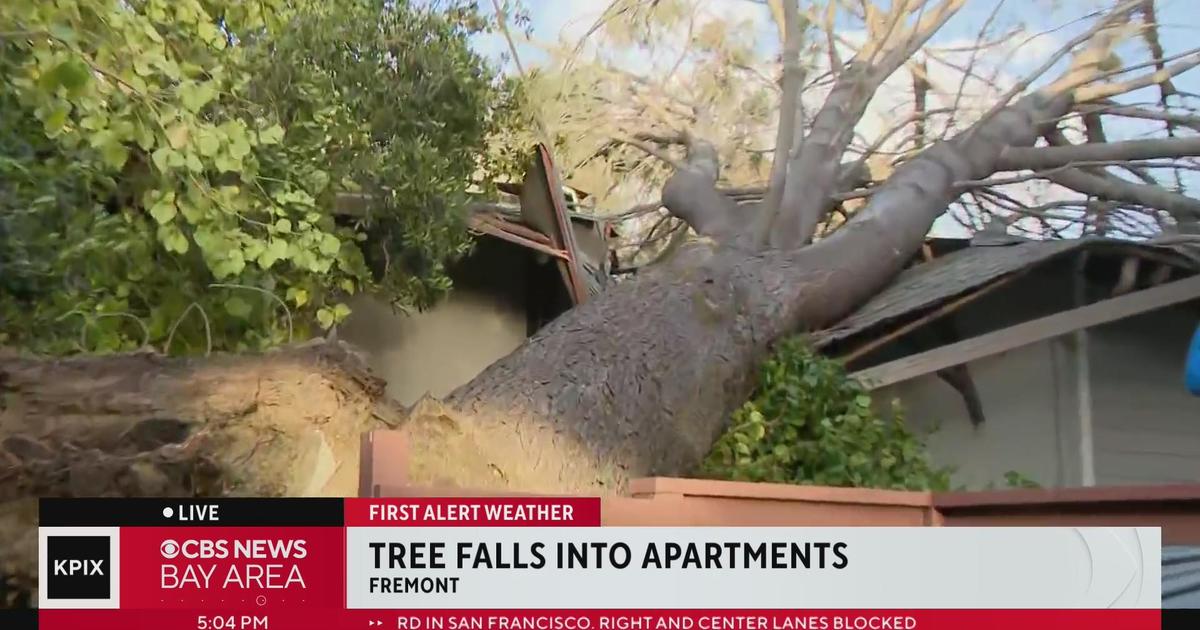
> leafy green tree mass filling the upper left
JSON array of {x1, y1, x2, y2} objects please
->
[{"x1": 0, "y1": 0, "x2": 503, "y2": 353}]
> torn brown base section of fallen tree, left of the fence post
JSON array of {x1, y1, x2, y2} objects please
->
[{"x1": 0, "y1": 343, "x2": 392, "y2": 597}]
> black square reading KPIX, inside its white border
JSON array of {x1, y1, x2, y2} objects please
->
[{"x1": 46, "y1": 536, "x2": 113, "y2": 600}]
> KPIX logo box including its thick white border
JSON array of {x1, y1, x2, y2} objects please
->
[{"x1": 38, "y1": 527, "x2": 120, "y2": 608}]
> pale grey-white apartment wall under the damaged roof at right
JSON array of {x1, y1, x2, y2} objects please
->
[{"x1": 875, "y1": 300, "x2": 1200, "y2": 488}]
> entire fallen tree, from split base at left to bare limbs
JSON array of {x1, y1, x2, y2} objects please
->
[{"x1": 0, "y1": 0, "x2": 1200, "y2": 600}]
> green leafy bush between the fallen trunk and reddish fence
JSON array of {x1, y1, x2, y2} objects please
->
[{"x1": 702, "y1": 340, "x2": 949, "y2": 490}]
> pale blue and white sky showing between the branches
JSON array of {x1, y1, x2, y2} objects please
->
[{"x1": 463, "y1": 0, "x2": 1200, "y2": 235}]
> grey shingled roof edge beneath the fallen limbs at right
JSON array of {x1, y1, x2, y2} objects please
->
[{"x1": 810, "y1": 238, "x2": 1200, "y2": 348}]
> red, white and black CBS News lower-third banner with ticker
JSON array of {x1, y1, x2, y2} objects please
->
[{"x1": 0, "y1": 498, "x2": 1200, "y2": 630}]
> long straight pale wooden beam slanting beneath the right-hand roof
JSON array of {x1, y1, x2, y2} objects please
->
[{"x1": 851, "y1": 271, "x2": 1200, "y2": 389}]
